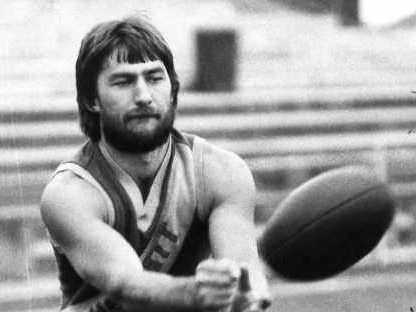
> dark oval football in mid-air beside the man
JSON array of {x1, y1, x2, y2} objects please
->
[{"x1": 258, "y1": 167, "x2": 394, "y2": 280}]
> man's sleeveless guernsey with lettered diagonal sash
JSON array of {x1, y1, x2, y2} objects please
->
[{"x1": 54, "y1": 130, "x2": 210, "y2": 312}]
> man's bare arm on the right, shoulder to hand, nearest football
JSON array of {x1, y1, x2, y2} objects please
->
[{"x1": 204, "y1": 146, "x2": 269, "y2": 310}]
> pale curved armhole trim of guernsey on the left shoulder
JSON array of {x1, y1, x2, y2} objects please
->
[{"x1": 52, "y1": 162, "x2": 115, "y2": 226}]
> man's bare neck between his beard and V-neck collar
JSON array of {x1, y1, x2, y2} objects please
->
[{"x1": 100, "y1": 138, "x2": 169, "y2": 181}]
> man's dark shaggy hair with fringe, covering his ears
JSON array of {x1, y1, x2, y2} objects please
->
[{"x1": 75, "y1": 16, "x2": 179, "y2": 141}]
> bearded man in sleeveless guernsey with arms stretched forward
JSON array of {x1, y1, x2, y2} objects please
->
[{"x1": 41, "y1": 17, "x2": 270, "y2": 312}]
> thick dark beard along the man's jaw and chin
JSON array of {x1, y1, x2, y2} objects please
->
[{"x1": 101, "y1": 107, "x2": 175, "y2": 154}]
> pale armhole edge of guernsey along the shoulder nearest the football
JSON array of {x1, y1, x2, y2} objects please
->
[{"x1": 193, "y1": 137, "x2": 210, "y2": 222}]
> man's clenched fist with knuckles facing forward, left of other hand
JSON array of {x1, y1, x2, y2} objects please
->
[{"x1": 194, "y1": 259, "x2": 241, "y2": 311}]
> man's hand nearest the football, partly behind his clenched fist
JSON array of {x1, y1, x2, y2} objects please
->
[{"x1": 232, "y1": 265, "x2": 271, "y2": 312}]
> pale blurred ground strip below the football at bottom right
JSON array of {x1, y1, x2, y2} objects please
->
[{"x1": 271, "y1": 271, "x2": 416, "y2": 312}]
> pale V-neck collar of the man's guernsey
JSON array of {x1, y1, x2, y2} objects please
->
[{"x1": 99, "y1": 137, "x2": 172, "y2": 232}]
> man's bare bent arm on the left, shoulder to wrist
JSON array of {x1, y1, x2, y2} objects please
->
[{"x1": 41, "y1": 173, "x2": 202, "y2": 311}]
